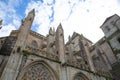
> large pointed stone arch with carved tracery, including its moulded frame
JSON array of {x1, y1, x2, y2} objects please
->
[{"x1": 18, "y1": 61, "x2": 58, "y2": 80}]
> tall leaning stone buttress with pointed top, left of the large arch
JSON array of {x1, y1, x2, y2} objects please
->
[{"x1": 0, "y1": 9, "x2": 35, "y2": 80}]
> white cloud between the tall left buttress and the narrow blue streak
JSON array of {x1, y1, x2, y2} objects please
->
[{"x1": 25, "y1": 1, "x2": 51, "y2": 35}]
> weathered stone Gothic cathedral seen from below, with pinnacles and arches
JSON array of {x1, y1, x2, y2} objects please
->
[{"x1": 0, "y1": 9, "x2": 120, "y2": 80}]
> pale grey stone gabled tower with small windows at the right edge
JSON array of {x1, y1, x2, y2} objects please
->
[{"x1": 101, "y1": 14, "x2": 120, "y2": 59}]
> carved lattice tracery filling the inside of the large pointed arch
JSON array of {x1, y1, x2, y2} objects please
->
[{"x1": 18, "y1": 64, "x2": 56, "y2": 80}]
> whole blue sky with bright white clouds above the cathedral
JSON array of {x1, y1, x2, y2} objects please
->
[{"x1": 0, "y1": 0, "x2": 120, "y2": 43}]
